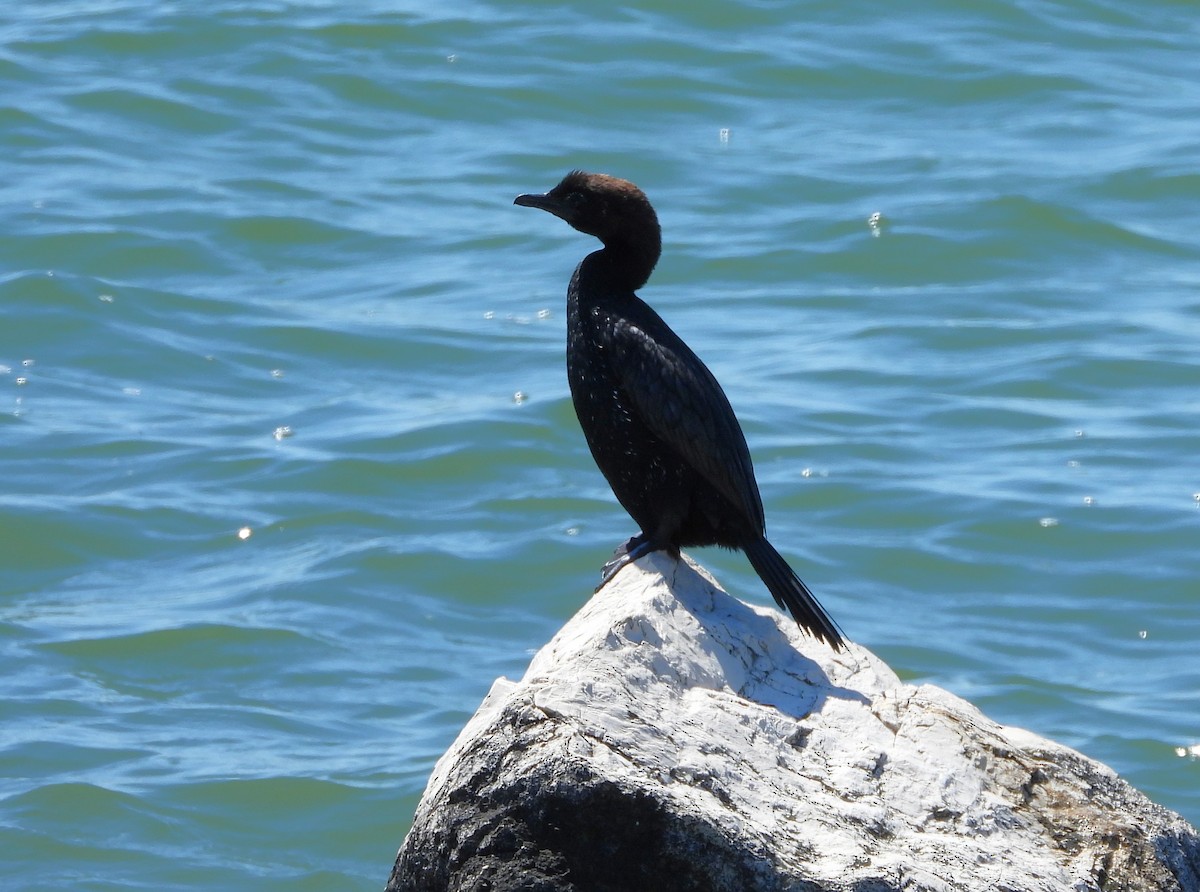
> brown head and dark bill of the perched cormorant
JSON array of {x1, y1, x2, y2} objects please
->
[{"x1": 512, "y1": 170, "x2": 662, "y2": 287}]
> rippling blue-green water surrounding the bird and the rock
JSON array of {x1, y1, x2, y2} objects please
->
[{"x1": 0, "y1": 0, "x2": 1200, "y2": 890}]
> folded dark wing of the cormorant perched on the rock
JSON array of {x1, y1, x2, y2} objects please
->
[{"x1": 611, "y1": 307, "x2": 763, "y2": 529}]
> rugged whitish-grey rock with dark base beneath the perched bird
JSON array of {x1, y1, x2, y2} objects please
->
[{"x1": 388, "y1": 553, "x2": 1200, "y2": 892}]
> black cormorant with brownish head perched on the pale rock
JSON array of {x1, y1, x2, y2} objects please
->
[{"x1": 514, "y1": 170, "x2": 844, "y2": 649}]
